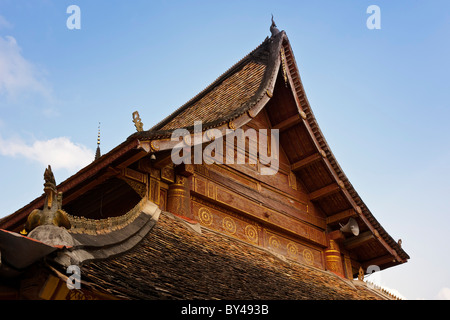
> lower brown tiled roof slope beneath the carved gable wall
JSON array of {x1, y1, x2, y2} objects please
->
[{"x1": 81, "y1": 212, "x2": 383, "y2": 300}]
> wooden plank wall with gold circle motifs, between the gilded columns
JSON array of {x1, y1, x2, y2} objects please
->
[{"x1": 183, "y1": 112, "x2": 327, "y2": 269}]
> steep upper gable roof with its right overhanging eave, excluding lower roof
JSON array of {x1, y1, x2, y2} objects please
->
[{"x1": 128, "y1": 31, "x2": 409, "y2": 268}]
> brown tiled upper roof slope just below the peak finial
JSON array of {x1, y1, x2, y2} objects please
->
[{"x1": 129, "y1": 32, "x2": 284, "y2": 139}]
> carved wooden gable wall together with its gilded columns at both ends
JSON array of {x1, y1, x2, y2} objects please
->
[{"x1": 134, "y1": 112, "x2": 351, "y2": 276}]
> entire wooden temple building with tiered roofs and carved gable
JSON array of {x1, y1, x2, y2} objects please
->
[{"x1": 0, "y1": 24, "x2": 409, "y2": 300}]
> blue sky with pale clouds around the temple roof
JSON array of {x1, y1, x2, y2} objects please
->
[{"x1": 0, "y1": 0, "x2": 450, "y2": 299}]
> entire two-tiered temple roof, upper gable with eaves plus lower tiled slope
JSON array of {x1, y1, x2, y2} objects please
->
[{"x1": 0, "y1": 25, "x2": 409, "y2": 299}]
